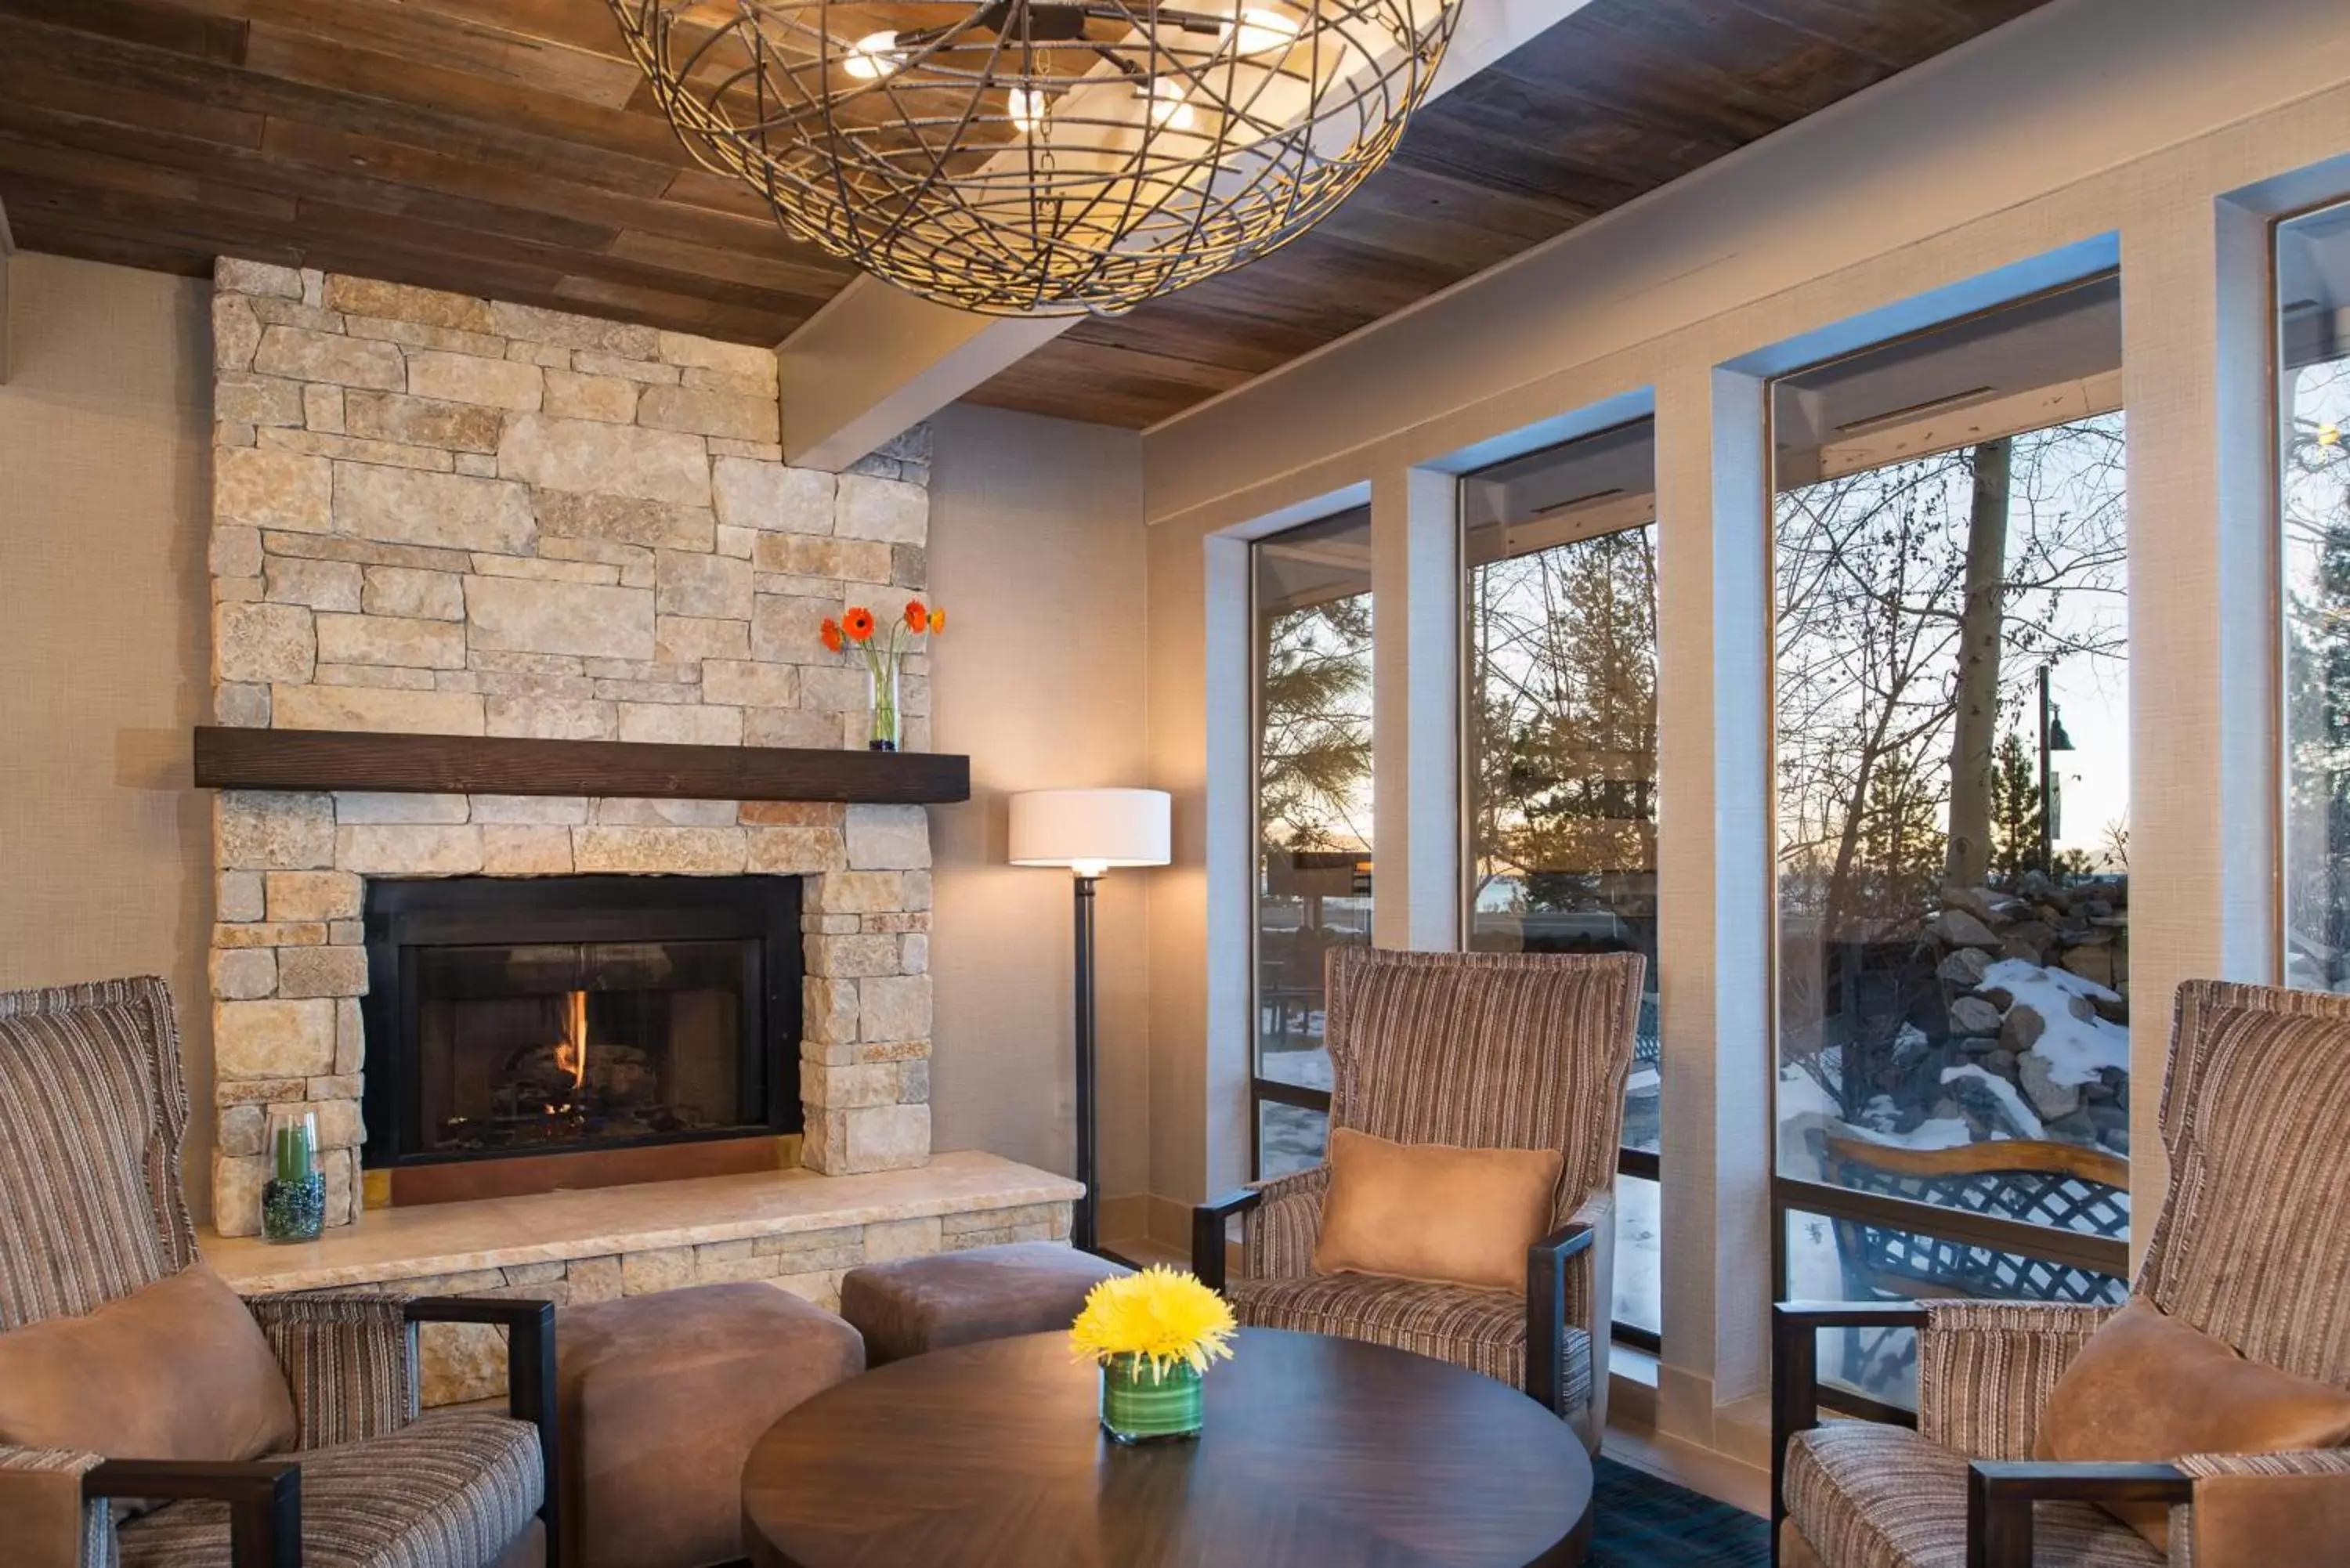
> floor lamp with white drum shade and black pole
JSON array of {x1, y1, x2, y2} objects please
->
[{"x1": 1010, "y1": 790, "x2": 1168, "y2": 1253}]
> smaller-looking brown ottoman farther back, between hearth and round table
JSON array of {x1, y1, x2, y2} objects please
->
[{"x1": 841, "y1": 1241, "x2": 1130, "y2": 1366}]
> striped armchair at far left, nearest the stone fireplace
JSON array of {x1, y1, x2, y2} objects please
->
[{"x1": 0, "y1": 978, "x2": 555, "y2": 1568}]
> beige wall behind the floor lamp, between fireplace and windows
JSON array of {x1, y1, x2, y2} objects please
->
[{"x1": 931, "y1": 404, "x2": 1163, "y2": 1197}]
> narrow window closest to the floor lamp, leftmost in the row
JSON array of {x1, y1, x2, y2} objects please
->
[{"x1": 1253, "y1": 508, "x2": 1370, "y2": 1178}]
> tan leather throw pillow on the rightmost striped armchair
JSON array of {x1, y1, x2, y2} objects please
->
[{"x1": 2033, "y1": 1298, "x2": 2350, "y2": 1552}]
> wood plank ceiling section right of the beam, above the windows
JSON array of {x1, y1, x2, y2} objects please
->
[{"x1": 971, "y1": 0, "x2": 2044, "y2": 425}]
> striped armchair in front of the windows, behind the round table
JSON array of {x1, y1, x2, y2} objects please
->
[{"x1": 1191, "y1": 948, "x2": 1645, "y2": 1453}]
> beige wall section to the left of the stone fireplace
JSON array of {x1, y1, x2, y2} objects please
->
[{"x1": 0, "y1": 254, "x2": 212, "y2": 1206}]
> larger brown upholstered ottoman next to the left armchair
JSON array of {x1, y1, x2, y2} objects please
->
[{"x1": 555, "y1": 1284, "x2": 865, "y2": 1568}]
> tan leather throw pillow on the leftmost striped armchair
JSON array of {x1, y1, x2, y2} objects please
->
[{"x1": 0, "y1": 1263, "x2": 294, "y2": 1460}]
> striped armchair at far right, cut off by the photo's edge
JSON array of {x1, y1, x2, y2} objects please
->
[{"x1": 1772, "y1": 981, "x2": 2350, "y2": 1568}]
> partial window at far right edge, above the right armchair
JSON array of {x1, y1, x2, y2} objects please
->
[{"x1": 2277, "y1": 204, "x2": 2350, "y2": 990}]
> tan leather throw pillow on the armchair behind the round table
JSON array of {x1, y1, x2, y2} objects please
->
[{"x1": 1314, "y1": 1126, "x2": 1565, "y2": 1291}]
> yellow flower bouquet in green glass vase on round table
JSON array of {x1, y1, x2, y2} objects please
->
[{"x1": 1069, "y1": 1267, "x2": 1234, "y2": 1443}]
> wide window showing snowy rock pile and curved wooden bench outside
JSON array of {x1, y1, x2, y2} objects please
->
[{"x1": 1772, "y1": 277, "x2": 2129, "y2": 1401}]
